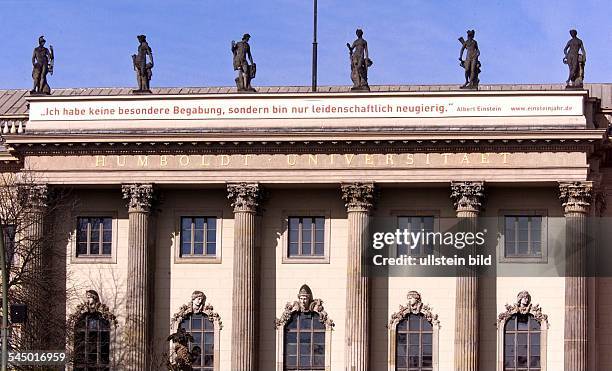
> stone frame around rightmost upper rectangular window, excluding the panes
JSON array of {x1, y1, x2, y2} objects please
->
[{"x1": 497, "y1": 209, "x2": 549, "y2": 264}]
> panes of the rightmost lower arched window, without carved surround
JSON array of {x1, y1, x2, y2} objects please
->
[{"x1": 503, "y1": 314, "x2": 542, "y2": 371}]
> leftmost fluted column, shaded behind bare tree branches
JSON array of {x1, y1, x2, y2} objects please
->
[{"x1": 17, "y1": 184, "x2": 49, "y2": 349}]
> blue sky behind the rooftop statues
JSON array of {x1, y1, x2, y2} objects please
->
[{"x1": 0, "y1": 0, "x2": 612, "y2": 89}]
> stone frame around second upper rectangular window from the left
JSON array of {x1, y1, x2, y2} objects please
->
[{"x1": 172, "y1": 209, "x2": 223, "y2": 264}]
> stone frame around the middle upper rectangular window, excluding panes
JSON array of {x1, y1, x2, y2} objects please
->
[{"x1": 280, "y1": 209, "x2": 331, "y2": 264}]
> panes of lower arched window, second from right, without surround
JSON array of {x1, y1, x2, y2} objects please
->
[{"x1": 395, "y1": 314, "x2": 433, "y2": 371}]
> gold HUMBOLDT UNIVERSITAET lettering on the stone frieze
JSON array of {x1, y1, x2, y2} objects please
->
[{"x1": 90, "y1": 153, "x2": 520, "y2": 169}]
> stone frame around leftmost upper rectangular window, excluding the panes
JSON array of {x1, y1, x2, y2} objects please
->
[{"x1": 70, "y1": 210, "x2": 119, "y2": 264}]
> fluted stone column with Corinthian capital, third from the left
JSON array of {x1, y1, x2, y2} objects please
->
[{"x1": 227, "y1": 183, "x2": 262, "y2": 371}]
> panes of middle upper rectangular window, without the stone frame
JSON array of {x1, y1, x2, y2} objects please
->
[{"x1": 288, "y1": 216, "x2": 325, "y2": 258}]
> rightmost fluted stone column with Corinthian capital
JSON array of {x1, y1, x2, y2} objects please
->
[{"x1": 559, "y1": 182, "x2": 593, "y2": 371}]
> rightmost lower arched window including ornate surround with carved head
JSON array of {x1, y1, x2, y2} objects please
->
[{"x1": 497, "y1": 291, "x2": 548, "y2": 371}]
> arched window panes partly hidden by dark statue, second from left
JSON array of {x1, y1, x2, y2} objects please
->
[{"x1": 180, "y1": 313, "x2": 215, "y2": 371}]
